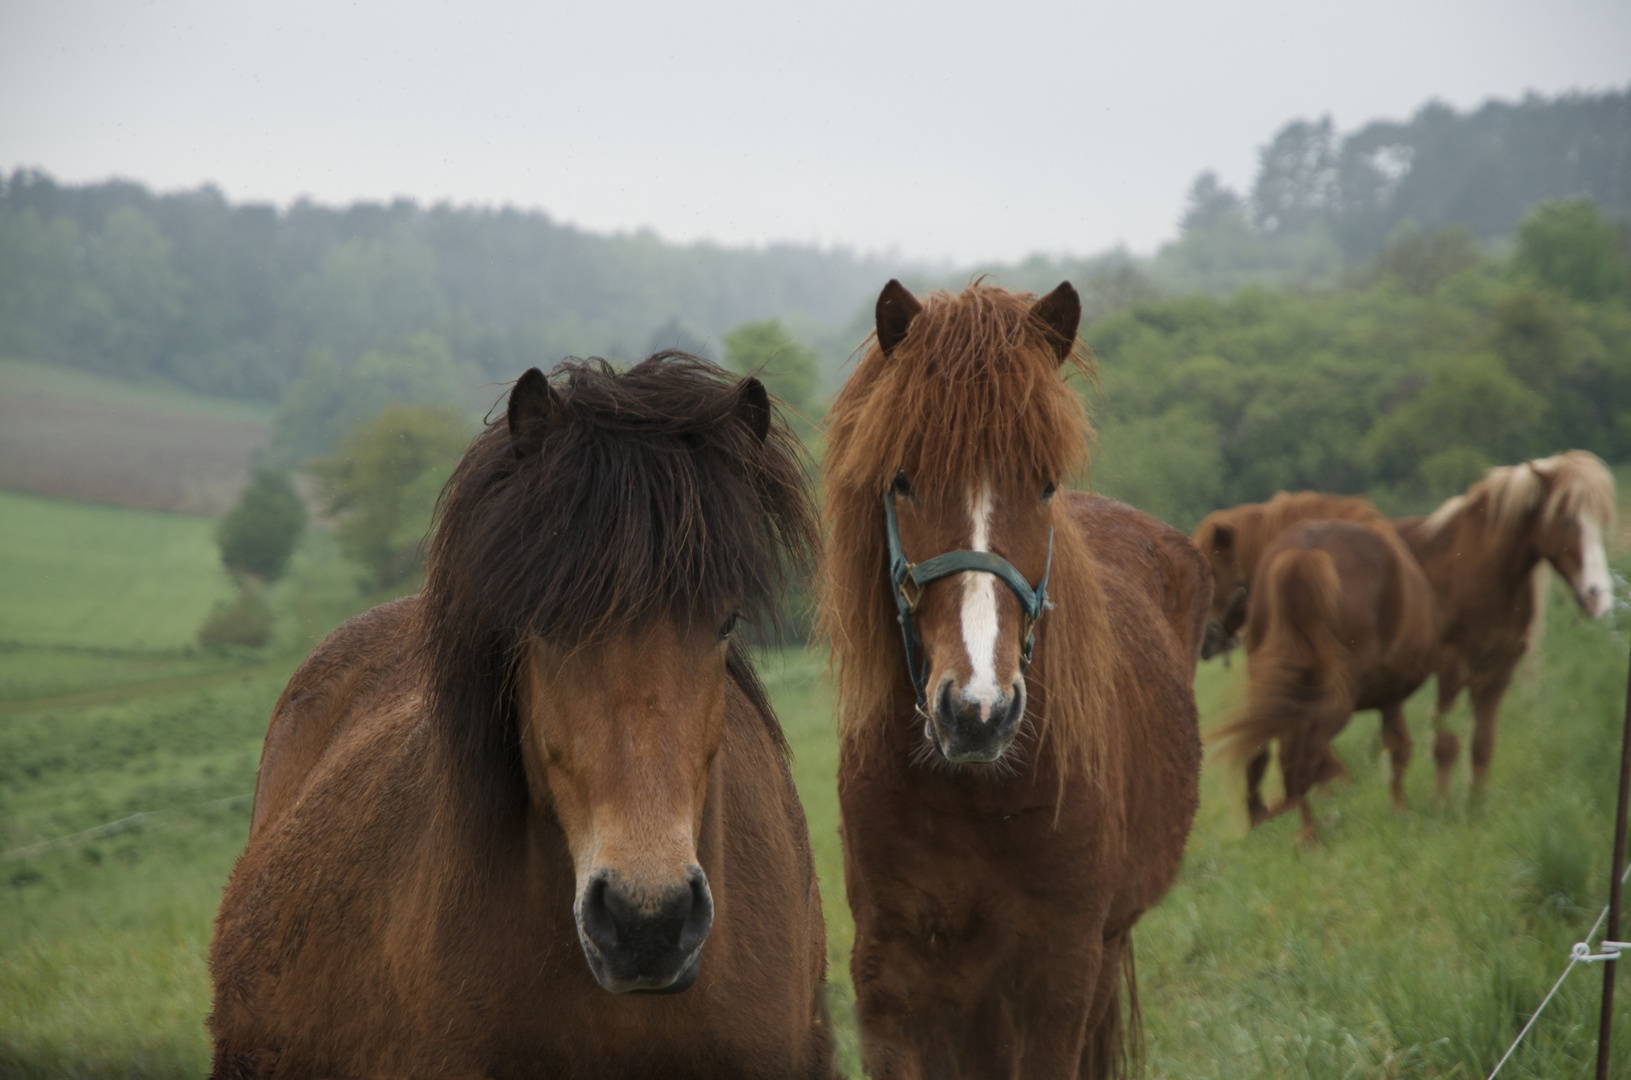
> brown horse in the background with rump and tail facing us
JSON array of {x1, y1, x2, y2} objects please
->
[{"x1": 1215, "y1": 519, "x2": 1439, "y2": 842}]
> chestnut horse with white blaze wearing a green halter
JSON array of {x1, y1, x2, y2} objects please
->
[{"x1": 820, "y1": 281, "x2": 1207, "y2": 1078}]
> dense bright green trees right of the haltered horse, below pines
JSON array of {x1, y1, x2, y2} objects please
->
[{"x1": 1086, "y1": 199, "x2": 1631, "y2": 529}]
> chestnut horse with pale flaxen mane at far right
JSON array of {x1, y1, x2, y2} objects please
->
[{"x1": 1398, "y1": 450, "x2": 1615, "y2": 799}]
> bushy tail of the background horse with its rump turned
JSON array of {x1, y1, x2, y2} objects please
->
[{"x1": 1213, "y1": 548, "x2": 1352, "y2": 799}]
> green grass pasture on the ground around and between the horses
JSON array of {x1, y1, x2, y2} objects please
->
[{"x1": 0, "y1": 496, "x2": 1631, "y2": 1080}]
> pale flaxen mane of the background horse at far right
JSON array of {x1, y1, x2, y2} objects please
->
[{"x1": 1422, "y1": 450, "x2": 1615, "y2": 537}]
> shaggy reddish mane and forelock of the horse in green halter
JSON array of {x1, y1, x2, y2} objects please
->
[{"x1": 820, "y1": 284, "x2": 1114, "y2": 796}]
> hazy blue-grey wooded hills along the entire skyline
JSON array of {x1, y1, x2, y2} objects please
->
[{"x1": 0, "y1": 88, "x2": 1631, "y2": 408}]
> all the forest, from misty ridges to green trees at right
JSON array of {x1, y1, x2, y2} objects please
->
[{"x1": 0, "y1": 90, "x2": 1631, "y2": 558}]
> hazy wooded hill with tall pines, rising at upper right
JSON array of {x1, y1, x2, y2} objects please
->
[{"x1": 1028, "y1": 86, "x2": 1631, "y2": 295}]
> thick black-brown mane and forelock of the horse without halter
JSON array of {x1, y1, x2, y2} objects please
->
[{"x1": 419, "y1": 351, "x2": 819, "y2": 822}]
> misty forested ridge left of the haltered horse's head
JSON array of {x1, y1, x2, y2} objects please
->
[{"x1": 0, "y1": 171, "x2": 889, "y2": 412}]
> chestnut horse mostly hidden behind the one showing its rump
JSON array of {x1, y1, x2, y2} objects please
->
[{"x1": 1194, "y1": 491, "x2": 1381, "y2": 659}]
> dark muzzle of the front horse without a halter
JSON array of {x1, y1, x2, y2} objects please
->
[{"x1": 576, "y1": 866, "x2": 713, "y2": 994}]
